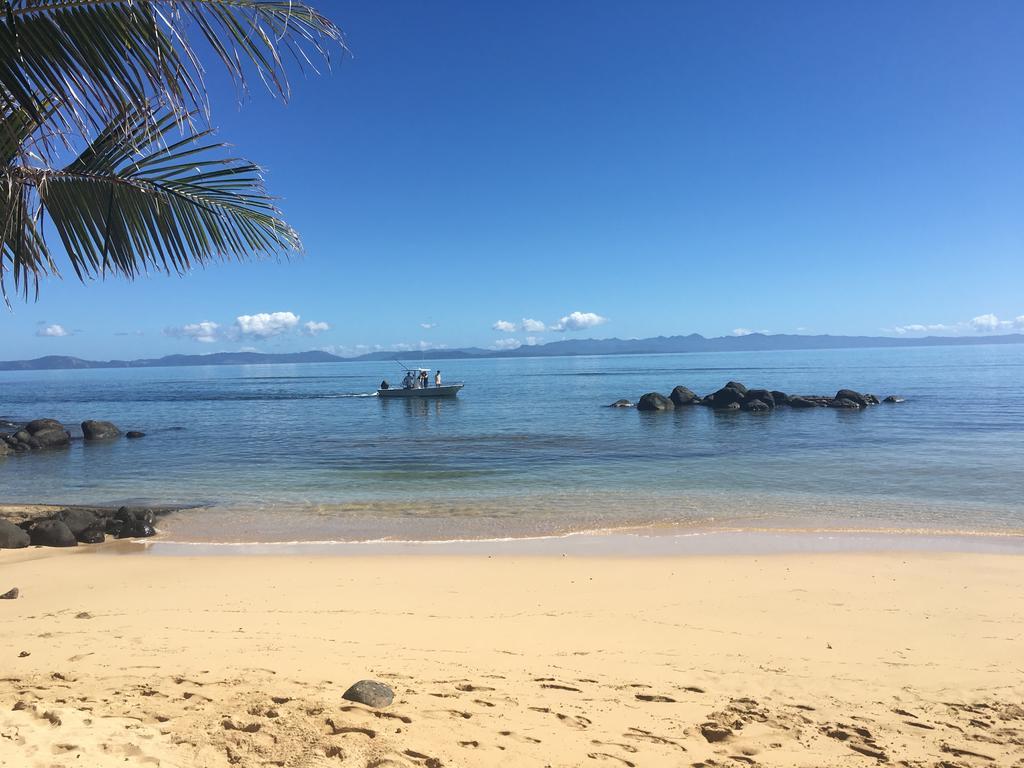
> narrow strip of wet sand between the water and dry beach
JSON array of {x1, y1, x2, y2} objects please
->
[{"x1": 6, "y1": 504, "x2": 1024, "y2": 562}]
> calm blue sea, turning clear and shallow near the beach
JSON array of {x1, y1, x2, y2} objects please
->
[{"x1": 0, "y1": 345, "x2": 1024, "y2": 541}]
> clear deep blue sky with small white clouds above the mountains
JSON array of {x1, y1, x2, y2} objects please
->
[{"x1": 0, "y1": 0, "x2": 1024, "y2": 359}]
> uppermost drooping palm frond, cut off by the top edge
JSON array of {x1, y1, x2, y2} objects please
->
[{"x1": 0, "y1": 0, "x2": 344, "y2": 138}]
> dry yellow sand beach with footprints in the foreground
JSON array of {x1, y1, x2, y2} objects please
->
[{"x1": 0, "y1": 548, "x2": 1024, "y2": 768}]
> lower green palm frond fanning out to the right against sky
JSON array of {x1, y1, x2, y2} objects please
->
[{"x1": 0, "y1": 99, "x2": 301, "y2": 297}]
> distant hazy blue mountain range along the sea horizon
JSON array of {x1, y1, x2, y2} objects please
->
[{"x1": 0, "y1": 334, "x2": 1024, "y2": 371}]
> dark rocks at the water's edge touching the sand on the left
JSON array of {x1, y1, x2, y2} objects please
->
[{"x1": 0, "y1": 507, "x2": 157, "y2": 549}]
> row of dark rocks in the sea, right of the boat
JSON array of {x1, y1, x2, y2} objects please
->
[{"x1": 611, "y1": 381, "x2": 903, "y2": 413}]
